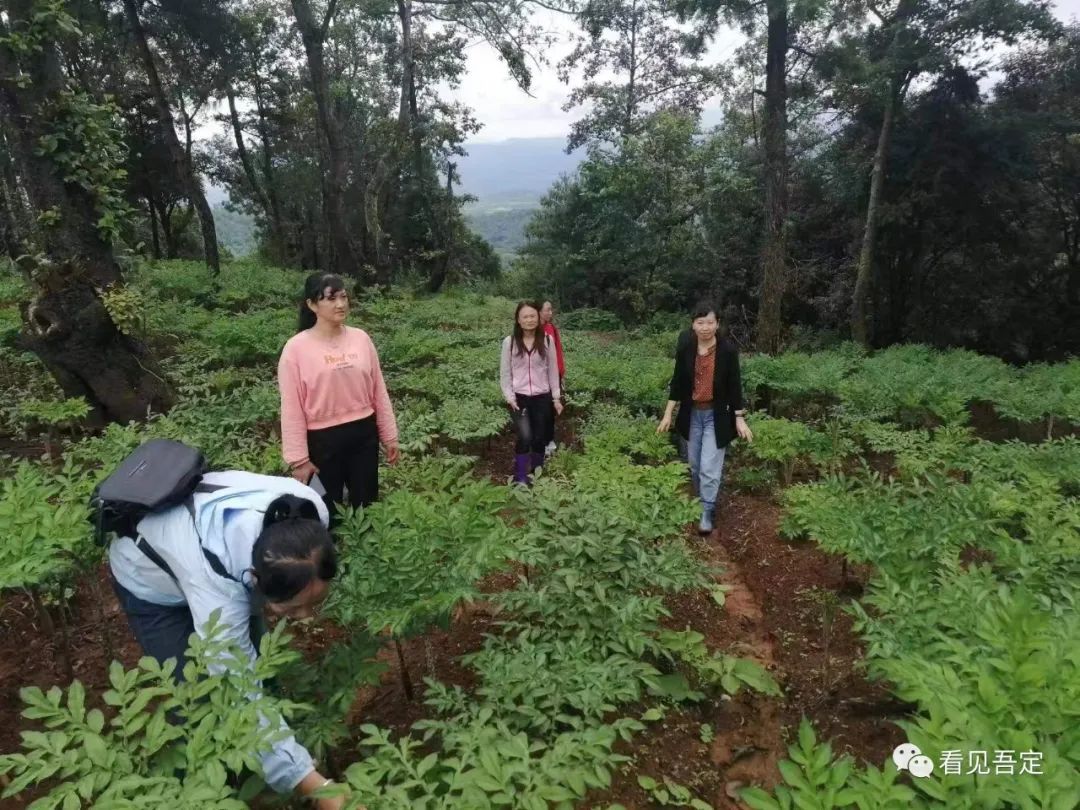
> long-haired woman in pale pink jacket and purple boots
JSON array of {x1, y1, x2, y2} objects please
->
[{"x1": 499, "y1": 301, "x2": 563, "y2": 484}]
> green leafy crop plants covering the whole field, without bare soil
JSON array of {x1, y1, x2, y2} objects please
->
[{"x1": 0, "y1": 262, "x2": 1080, "y2": 809}]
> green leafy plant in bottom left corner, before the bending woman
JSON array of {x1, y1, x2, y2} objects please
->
[{"x1": 0, "y1": 613, "x2": 308, "y2": 810}]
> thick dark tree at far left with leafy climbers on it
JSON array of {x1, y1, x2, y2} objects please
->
[{"x1": 0, "y1": 0, "x2": 173, "y2": 421}]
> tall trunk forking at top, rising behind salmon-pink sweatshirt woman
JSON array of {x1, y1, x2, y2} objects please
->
[{"x1": 292, "y1": 0, "x2": 361, "y2": 275}]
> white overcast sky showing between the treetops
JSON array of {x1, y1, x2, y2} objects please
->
[{"x1": 454, "y1": 0, "x2": 1080, "y2": 143}]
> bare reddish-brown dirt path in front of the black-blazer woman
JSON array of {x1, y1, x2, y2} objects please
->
[{"x1": 588, "y1": 496, "x2": 906, "y2": 810}]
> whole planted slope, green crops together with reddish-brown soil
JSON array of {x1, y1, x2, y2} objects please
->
[{"x1": 0, "y1": 261, "x2": 1080, "y2": 810}]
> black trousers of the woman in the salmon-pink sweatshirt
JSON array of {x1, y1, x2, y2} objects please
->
[{"x1": 308, "y1": 414, "x2": 379, "y2": 515}]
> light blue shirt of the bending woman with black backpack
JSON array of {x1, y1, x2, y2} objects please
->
[{"x1": 109, "y1": 471, "x2": 329, "y2": 793}]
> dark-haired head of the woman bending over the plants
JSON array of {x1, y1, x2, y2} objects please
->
[{"x1": 252, "y1": 495, "x2": 337, "y2": 602}]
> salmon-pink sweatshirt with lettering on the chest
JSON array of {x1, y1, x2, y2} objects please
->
[{"x1": 278, "y1": 326, "x2": 397, "y2": 467}]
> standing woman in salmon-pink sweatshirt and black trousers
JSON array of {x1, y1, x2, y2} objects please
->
[{"x1": 278, "y1": 273, "x2": 401, "y2": 514}]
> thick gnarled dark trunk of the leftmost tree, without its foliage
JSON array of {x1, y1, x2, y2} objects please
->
[{"x1": 0, "y1": 9, "x2": 173, "y2": 422}]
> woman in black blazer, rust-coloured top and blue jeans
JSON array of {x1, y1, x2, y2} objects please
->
[{"x1": 657, "y1": 301, "x2": 754, "y2": 535}]
